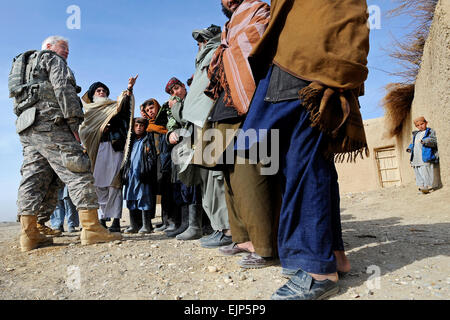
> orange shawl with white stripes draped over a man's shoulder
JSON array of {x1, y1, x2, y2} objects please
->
[{"x1": 205, "y1": 0, "x2": 270, "y2": 115}]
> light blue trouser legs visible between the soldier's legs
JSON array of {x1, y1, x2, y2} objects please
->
[{"x1": 50, "y1": 186, "x2": 80, "y2": 229}]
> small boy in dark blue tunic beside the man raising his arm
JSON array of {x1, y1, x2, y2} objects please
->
[{"x1": 123, "y1": 118, "x2": 157, "y2": 234}]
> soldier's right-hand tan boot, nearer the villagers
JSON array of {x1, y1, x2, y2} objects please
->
[{"x1": 78, "y1": 209, "x2": 122, "y2": 246}]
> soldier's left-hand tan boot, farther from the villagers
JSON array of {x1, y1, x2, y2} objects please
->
[{"x1": 19, "y1": 216, "x2": 53, "y2": 252}]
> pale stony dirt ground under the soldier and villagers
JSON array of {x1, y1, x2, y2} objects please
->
[{"x1": 0, "y1": 185, "x2": 450, "y2": 300}]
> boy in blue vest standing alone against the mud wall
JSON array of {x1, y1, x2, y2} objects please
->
[{"x1": 406, "y1": 117, "x2": 439, "y2": 194}]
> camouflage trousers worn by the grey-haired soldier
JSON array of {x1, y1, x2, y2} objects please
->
[{"x1": 17, "y1": 121, "x2": 98, "y2": 216}]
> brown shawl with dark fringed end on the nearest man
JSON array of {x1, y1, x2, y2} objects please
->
[{"x1": 249, "y1": 0, "x2": 369, "y2": 161}]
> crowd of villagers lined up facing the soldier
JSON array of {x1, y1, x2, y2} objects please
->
[{"x1": 64, "y1": 0, "x2": 369, "y2": 299}]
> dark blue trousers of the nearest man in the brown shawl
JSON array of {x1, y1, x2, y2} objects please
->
[{"x1": 243, "y1": 65, "x2": 344, "y2": 274}]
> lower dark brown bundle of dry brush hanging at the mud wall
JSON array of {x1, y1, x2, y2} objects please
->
[{"x1": 383, "y1": 83, "x2": 415, "y2": 137}]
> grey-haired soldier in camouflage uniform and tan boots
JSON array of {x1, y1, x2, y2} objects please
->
[{"x1": 11, "y1": 36, "x2": 121, "y2": 251}]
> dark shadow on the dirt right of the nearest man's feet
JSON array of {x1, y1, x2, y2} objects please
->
[{"x1": 339, "y1": 214, "x2": 450, "y2": 294}]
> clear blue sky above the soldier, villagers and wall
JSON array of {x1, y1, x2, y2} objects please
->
[{"x1": 0, "y1": 0, "x2": 411, "y2": 221}]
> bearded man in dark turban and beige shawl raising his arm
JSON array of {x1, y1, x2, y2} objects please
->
[{"x1": 79, "y1": 76, "x2": 137, "y2": 232}]
